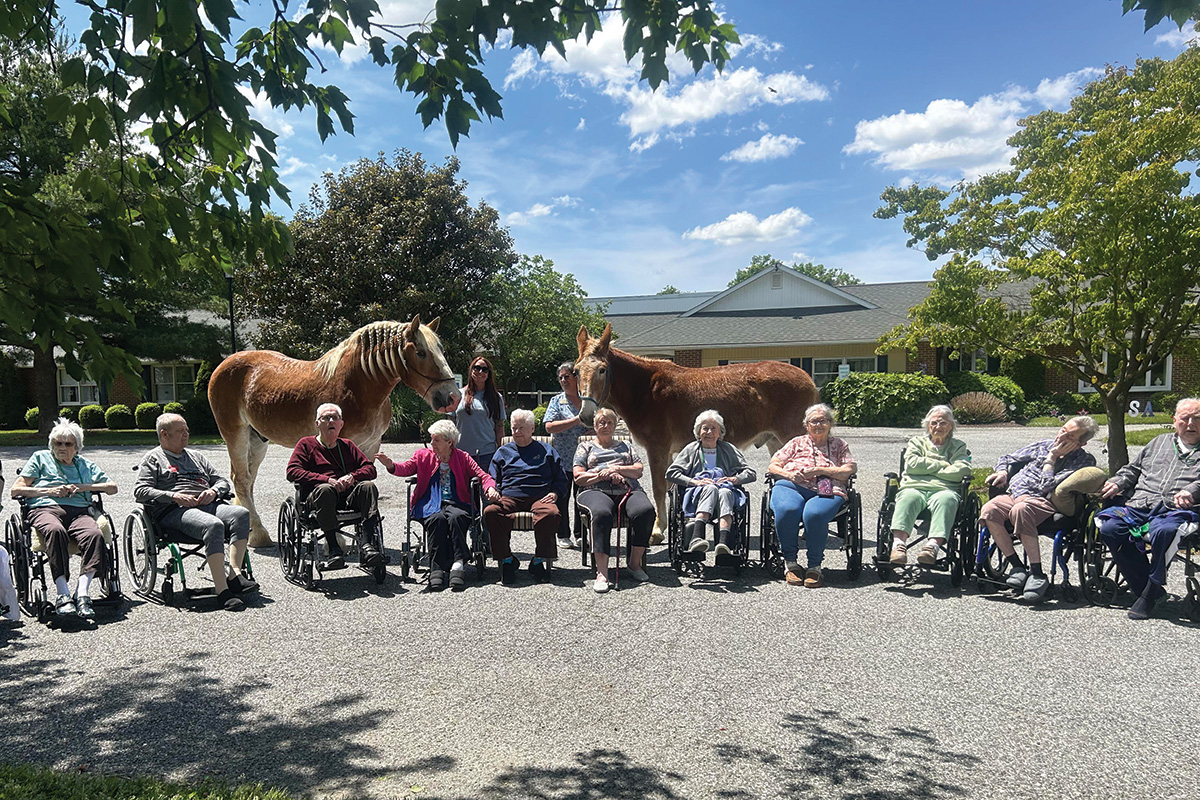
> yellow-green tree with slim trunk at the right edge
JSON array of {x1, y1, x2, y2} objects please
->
[{"x1": 876, "y1": 47, "x2": 1200, "y2": 469}]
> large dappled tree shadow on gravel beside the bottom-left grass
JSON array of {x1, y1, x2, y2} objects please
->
[{"x1": 0, "y1": 642, "x2": 456, "y2": 796}]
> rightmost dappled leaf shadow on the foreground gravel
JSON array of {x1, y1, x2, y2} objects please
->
[{"x1": 716, "y1": 710, "x2": 979, "y2": 800}]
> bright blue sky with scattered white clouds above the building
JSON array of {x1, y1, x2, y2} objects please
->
[{"x1": 241, "y1": 0, "x2": 1190, "y2": 295}]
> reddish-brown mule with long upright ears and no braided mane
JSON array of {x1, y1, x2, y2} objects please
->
[{"x1": 575, "y1": 325, "x2": 817, "y2": 531}]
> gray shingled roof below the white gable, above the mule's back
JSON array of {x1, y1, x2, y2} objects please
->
[{"x1": 606, "y1": 281, "x2": 930, "y2": 350}]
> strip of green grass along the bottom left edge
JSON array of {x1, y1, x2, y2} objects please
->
[{"x1": 0, "y1": 764, "x2": 290, "y2": 800}]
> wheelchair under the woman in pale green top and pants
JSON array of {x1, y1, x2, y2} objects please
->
[{"x1": 875, "y1": 450, "x2": 982, "y2": 589}]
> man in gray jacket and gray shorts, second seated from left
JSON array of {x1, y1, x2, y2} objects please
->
[{"x1": 133, "y1": 414, "x2": 258, "y2": 610}]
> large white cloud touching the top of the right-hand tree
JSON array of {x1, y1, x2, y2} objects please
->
[{"x1": 842, "y1": 67, "x2": 1102, "y2": 182}]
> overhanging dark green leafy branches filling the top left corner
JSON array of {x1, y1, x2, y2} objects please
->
[{"x1": 0, "y1": 0, "x2": 738, "y2": 391}]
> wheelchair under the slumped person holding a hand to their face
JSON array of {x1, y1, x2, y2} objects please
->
[{"x1": 974, "y1": 465, "x2": 1098, "y2": 603}]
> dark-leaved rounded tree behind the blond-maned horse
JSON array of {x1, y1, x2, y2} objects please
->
[{"x1": 238, "y1": 150, "x2": 517, "y2": 365}]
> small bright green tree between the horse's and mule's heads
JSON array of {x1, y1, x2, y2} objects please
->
[{"x1": 480, "y1": 255, "x2": 607, "y2": 392}]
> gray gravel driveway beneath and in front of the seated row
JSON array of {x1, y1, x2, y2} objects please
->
[{"x1": 0, "y1": 427, "x2": 1200, "y2": 800}]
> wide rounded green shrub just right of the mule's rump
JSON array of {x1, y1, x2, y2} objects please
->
[{"x1": 821, "y1": 372, "x2": 947, "y2": 426}]
